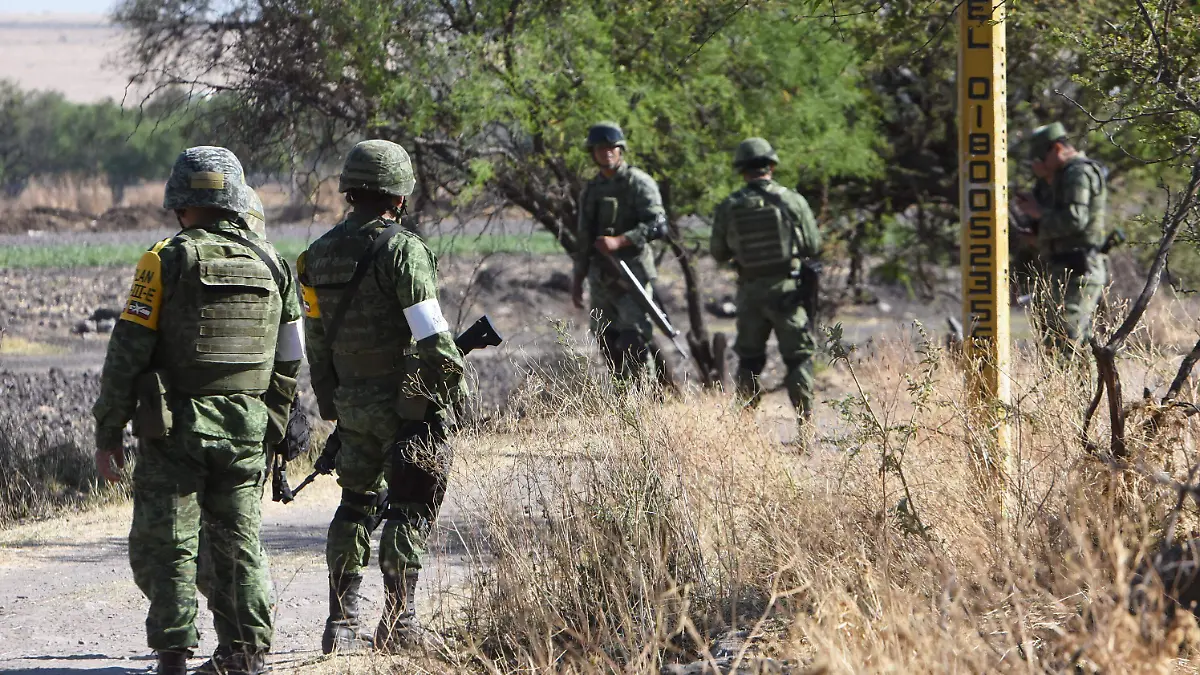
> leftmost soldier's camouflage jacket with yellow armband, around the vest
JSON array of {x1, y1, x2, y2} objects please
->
[{"x1": 92, "y1": 221, "x2": 300, "y2": 449}]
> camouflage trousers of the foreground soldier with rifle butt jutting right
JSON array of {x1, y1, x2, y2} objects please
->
[{"x1": 325, "y1": 401, "x2": 451, "y2": 577}]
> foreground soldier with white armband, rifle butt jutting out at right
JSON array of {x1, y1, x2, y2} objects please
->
[{"x1": 296, "y1": 141, "x2": 463, "y2": 653}]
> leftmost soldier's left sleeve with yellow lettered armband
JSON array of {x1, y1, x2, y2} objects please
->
[{"x1": 91, "y1": 241, "x2": 179, "y2": 449}]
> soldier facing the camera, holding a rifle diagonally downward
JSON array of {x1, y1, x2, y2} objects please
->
[{"x1": 571, "y1": 121, "x2": 667, "y2": 377}]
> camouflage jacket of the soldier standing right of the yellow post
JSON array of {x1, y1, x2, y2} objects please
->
[{"x1": 1038, "y1": 153, "x2": 1108, "y2": 258}]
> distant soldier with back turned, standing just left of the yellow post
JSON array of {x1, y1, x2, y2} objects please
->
[{"x1": 710, "y1": 138, "x2": 821, "y2": 419}]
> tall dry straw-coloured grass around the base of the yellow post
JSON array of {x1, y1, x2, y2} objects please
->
[{"x1": 397, "y1": 329, "x2": 1198, "y2": 673}]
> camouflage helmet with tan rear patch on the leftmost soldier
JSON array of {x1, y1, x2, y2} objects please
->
[{"x1": 162, "y1": 145, "x2": 250, "y2": 214}]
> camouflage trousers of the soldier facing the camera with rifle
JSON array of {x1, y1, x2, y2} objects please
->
[{"x1": 589, "y1": 275, "x2": 656, "y2": 381}]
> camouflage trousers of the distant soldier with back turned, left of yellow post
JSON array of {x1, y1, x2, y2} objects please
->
[{"x1": 733, "y1": 277, "x2": 816, "y2": 416}]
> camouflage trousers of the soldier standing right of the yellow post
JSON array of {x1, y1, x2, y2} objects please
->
[{"x1": 1042, "y1": 253, "x2": 1109, "y2": 357}]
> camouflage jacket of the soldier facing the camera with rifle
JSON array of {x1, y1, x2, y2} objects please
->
[{"x1": 575, "y1": 162, "x2": 666, "y2": 282}]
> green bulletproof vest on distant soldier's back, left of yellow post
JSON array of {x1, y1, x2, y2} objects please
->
[{"x1": 730, "y1": 186, "x2": 794, "y2": 279}]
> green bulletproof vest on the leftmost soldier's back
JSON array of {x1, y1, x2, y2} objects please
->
[{"x1": 155, "y1": 229, "x2": 283, "y2": 396}]
